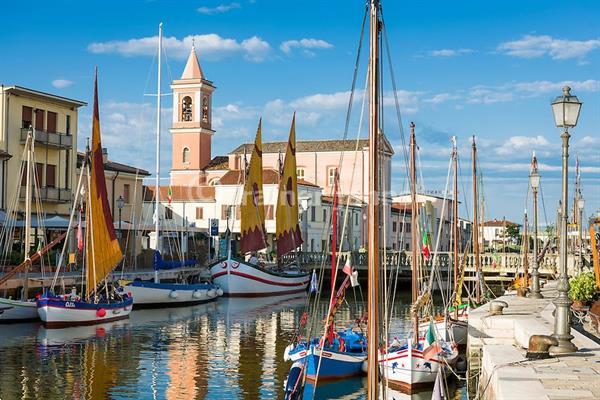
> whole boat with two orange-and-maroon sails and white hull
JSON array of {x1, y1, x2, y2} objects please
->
[{"x1": 210, "y1": 115, "x2": 310, "y2": 297}]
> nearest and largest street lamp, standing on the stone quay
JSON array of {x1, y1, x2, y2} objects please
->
[{"x1": 550, "y1": 86, "x2": 581, "y2": 354}]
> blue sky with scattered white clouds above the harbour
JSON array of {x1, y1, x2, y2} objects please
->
[{"x1": 0, "y1": 0, "x2": 600, "y2": 224}]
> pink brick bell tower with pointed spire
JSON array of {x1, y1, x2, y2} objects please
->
[{"x1": 171, "y1": 46, "x2": 215, "y2": 186}]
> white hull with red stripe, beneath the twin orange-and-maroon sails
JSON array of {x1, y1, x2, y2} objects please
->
[{"x1": 210, "y1": 260, "x2": 310, "y2": 297}]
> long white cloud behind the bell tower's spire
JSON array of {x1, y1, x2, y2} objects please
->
[{"x1": 88, "y1": 33, "x2": 271, "y2": 62}]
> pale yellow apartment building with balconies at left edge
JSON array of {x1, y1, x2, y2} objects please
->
[{"x1": 0, "y1": 86, "x2": 86, "y2": 215}]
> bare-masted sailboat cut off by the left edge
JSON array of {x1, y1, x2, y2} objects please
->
[{"x1": 0, "y1": 123, "x2": 66, "y2": 323}]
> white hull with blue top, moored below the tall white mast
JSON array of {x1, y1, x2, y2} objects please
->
[{"x1": 125, "y1": 282, "x2": 223, "y2": 309}]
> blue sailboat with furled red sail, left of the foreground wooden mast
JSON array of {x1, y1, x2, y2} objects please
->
[{"x1": 284, "y1": 173, "x2": 367, "y2": 382}]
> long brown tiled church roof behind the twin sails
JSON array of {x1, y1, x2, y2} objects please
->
[{"x1": 229, "y1": 136, "x2": 394, "y2": 154}]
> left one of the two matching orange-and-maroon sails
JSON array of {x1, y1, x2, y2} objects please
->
[{"x1": 240, "y1": 120, "x2": 267, "y2": 253}]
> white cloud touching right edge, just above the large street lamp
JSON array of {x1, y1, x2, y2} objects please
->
[{"x1": 498, "y1": 35, "x2": 600, "y2": 60}]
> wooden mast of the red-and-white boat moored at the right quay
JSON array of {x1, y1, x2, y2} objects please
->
[{"x1": 410, "y1": 122, "x2": 419, "y2": 344}]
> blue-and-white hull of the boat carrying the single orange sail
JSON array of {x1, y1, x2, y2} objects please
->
[{"x1": 37, "y1": 298, "x2": 133, "y2": 328}]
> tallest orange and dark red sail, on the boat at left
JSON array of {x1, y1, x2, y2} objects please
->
[{"x1": 86, "y1": 74, "x2": 123, "y2": 296}]
